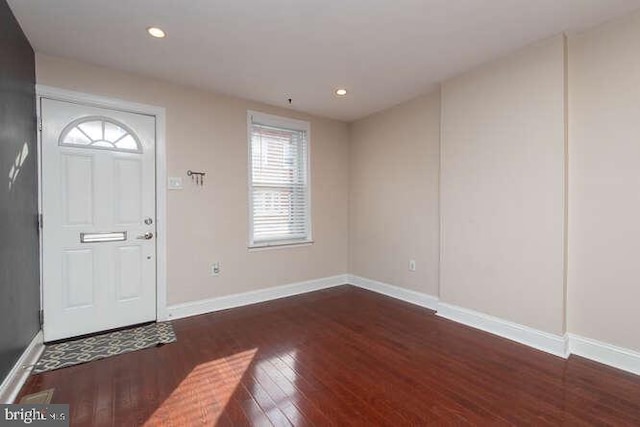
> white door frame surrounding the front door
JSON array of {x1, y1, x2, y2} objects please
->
[{"x1": 36, "y1": 85, "x2": 169, "y2": 321}]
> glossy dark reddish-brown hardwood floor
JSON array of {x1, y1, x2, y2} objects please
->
[{"x1": 17, "y1": 286, "x2": 640, "y2": 426}]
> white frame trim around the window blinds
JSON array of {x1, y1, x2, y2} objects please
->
[{"x1": 247, "y1": 110, "x2": 313, "y2": 250}]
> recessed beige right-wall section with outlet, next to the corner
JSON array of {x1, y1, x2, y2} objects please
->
[{"x1": 349, "y1": 92, "x2": 440, "y2": 296}]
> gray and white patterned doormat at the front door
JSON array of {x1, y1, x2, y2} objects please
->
[{"x1": 33, "y1": 322, "x2": 177, "y2": 374}]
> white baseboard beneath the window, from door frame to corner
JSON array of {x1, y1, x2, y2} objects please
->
[{"x1": 167, "y1": 274, "x2": 348, "y2": 319}]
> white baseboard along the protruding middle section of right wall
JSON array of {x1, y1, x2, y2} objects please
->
[{"x1": 437, "y1": 303, "x2": 569, "y2": 359}]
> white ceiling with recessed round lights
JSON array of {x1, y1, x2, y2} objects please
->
[{"x1": 9, "y1": 0, "x2": 640, "y2": 121}]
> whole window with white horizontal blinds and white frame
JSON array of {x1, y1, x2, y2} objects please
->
[{"x1": 249, "y1": 112, "x2": 311, "y2": 247}]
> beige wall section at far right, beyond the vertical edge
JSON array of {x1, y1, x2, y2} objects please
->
[{"x1": 568, "y1": 13, "x2": 640, "y2": 351}]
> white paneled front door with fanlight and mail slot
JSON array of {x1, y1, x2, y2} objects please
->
[{"x1": 41, "y1": 98, "x2": 156, "y2": 341}]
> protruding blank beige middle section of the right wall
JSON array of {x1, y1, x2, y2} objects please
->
[{"x1": 440, "y1": 36, "x2": 565, "y2": 334}]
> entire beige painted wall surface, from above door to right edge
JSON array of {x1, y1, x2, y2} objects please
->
[{"x1": 37, "y1": 13, "x2": 640, "y2": 358}]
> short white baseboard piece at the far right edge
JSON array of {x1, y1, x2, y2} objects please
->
[{"x1": 569, "y1": 334, "x2": 640, "y2": 375}]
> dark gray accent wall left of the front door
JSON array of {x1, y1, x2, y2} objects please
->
[{"x1": 0, "y1": 0, "x2": 40, "y2": 381}]
